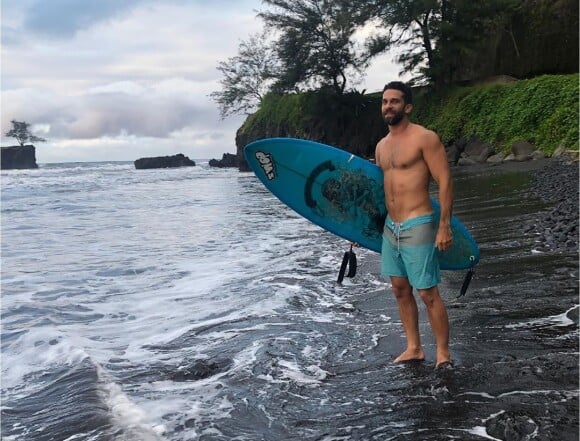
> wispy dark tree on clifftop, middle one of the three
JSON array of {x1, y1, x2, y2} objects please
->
[{"x1": 259, "y1": 0, "x2": 366, "y2": 95}]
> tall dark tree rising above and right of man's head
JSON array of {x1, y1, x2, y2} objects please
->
[{"x1": 368, "y1": 0, "x2": 519, "y2": 86}]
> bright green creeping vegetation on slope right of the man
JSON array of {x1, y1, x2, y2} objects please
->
[{"x1": 413, "y1": 74, "x2": 579, "y2": 154}]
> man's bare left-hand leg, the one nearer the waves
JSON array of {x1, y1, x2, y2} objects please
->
[{"x1": 391, "y1": 276, "x2": 425, "y2": 363}]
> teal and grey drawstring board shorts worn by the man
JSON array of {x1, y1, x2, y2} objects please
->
[{"x1": 381, "y1": 213, "x2": 441, "y2": 289}]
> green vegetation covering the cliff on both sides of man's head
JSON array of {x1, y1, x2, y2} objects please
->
[{"x1": 237, "y1": 74, "x2": 579, "y2": 157}]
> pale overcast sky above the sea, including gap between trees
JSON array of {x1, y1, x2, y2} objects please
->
[{"x1": 1, "y1": 0, "x2": 406, "y2": 163}]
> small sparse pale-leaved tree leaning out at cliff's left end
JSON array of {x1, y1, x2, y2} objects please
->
[{"x1": 210, "y1": 33, "x2": 278, "y2": 118}]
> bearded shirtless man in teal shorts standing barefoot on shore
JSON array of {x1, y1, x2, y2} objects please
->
[{"x1": 375, "y1": 81, "x2": 453, "y2": 367}]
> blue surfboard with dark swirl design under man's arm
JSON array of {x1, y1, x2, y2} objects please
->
[{"x1": 244, "y1": 138, "x2": 479, "y2": 270}]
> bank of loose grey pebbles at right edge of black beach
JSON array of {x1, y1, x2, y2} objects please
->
[{"x1": 526, "y1": 159, "x2": 579, "y2": 251}]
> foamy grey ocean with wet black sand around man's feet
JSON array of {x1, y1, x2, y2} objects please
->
[{"x1": 1, "y1": 162, "x2": 579, "y2": 441}]
